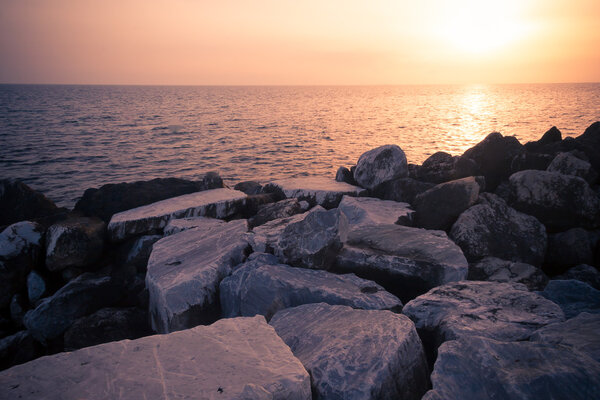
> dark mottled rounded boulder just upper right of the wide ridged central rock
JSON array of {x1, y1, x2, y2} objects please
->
[{"x1": 450, "y1": 193, "x2": 547, "y2": 266}]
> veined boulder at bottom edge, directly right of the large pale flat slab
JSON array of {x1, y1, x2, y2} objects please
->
[{"x1": 271, "y1": 303, "x2": 428, "y2": 399}]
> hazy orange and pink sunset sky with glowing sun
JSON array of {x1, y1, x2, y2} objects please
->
[{"x1": 0, "y1": 0, "x2": 600, "y2": 85}]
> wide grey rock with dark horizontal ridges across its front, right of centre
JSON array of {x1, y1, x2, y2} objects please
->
[{"x1": 334, "y1": 225, "x2": 468, "y2": 302}]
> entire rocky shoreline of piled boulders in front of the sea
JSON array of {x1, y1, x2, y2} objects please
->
[{"x1": 0, "y1": 122, "x2": 600, "y2": 400}]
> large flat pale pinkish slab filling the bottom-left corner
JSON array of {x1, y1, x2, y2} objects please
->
[{"x1": 0, "y1": 317, "x2": 311, "y2": 400}]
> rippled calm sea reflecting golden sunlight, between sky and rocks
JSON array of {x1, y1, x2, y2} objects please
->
[{"x1": 0, "y1": 84, "x2": 600, "y2": 206}]
